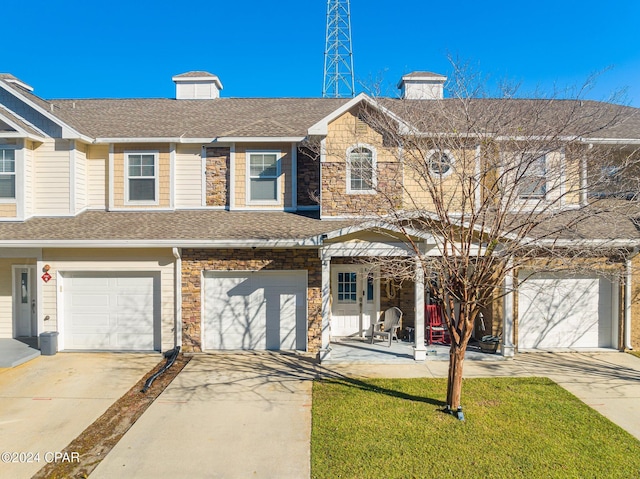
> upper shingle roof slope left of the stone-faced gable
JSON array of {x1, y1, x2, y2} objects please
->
[{"x1": 51, "y1": 98, "x2": 348, "y2": 138}]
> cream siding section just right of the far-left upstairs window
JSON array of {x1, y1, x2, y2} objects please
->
[{"x1": 34, "y1": 140, "x2": 70, "y2": 216}]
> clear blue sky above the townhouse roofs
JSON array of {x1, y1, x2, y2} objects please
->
[{"x1": 5, "y1": 0, "x2": 640, "y2": 107}]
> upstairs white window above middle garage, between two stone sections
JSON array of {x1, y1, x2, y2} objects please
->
[{"x1": 247, "y1": 151, "x2": 280, "y2": 204}]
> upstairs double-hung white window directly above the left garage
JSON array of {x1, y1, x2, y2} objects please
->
[{"x1": 125, "y1": 151, "x2": 158, "y2": 204}]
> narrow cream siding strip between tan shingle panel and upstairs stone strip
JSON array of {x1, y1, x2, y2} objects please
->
[{"x1": 175, "y1": 145, "x2": 203, "y2": 208}]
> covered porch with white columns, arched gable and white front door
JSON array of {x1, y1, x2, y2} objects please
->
[{"x1": 320, "y1": 223, "x2": 508, "y2": 363}]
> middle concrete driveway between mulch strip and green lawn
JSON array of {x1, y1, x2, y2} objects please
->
[{"x1": 91, "y1": 353, "x2": 316, "y2": 479}]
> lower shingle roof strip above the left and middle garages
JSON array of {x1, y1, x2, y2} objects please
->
[{"x1": 0, "y1": 210, "x2": 356, "y2": 247}]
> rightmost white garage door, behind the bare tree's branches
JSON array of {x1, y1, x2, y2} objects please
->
[{"x1": 518, "y1": 274, "x2": 614, "y2": 350}]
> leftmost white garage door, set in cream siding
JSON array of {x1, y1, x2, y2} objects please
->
[{"x1": 63, "y1": 272, "x2": 159, "y2": 351}]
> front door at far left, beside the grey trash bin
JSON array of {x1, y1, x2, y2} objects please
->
[{"x1": 13, "y1": 266, "x2": 37, "y2": 338}]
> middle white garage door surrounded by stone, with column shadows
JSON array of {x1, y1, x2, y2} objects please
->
[{"x1": 204, "y1": 271, "x2": 307, "y2": 350}]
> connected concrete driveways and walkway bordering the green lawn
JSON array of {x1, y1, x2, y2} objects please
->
[{"x1": 91, "y1": 352, "x2": 640, "y2": 479}]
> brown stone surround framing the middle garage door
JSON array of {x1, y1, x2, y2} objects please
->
[{"x1": 182, "y1": 249, "x2": 322, "y2": 353}]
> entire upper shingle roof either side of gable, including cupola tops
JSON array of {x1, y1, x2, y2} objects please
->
[{"x1": 0, "y1": 71, "x2": 640, "y2": 139}]
